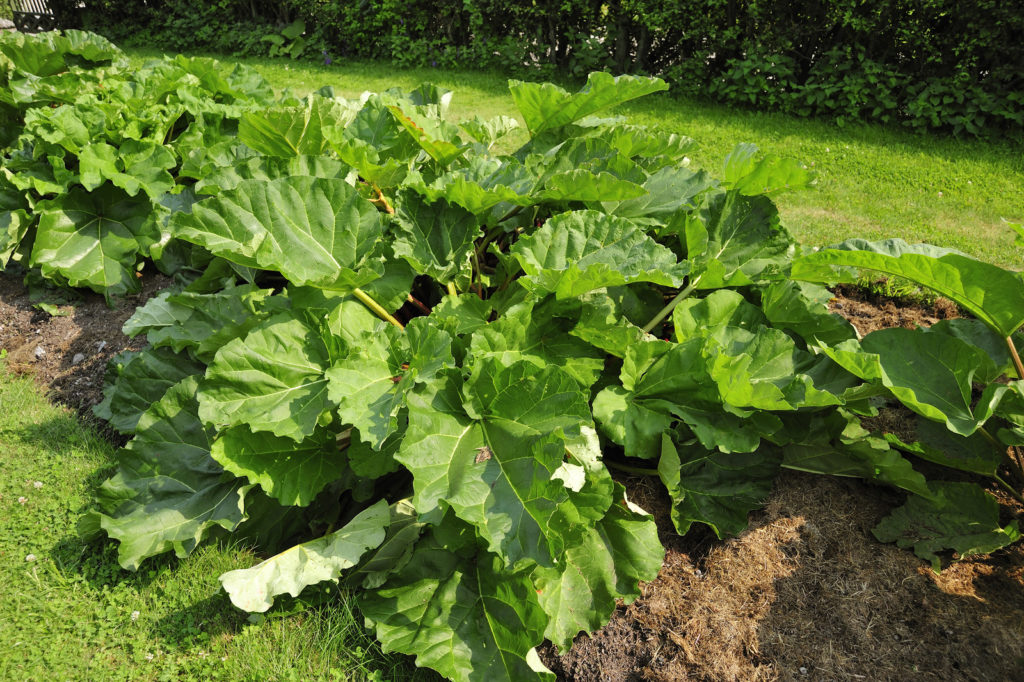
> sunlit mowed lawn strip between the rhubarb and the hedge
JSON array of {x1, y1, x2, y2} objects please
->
[{"x1": 129, "y1": 50, "x2": 1024, "y2": 269}]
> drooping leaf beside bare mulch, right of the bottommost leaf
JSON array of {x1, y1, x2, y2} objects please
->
[{"x1": 532, "y1": 486, "x2": 665, "y2": 650}]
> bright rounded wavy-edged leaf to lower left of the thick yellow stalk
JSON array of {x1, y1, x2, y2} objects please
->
[{"x1": 199, "y1": 313, "x2": 330, "y2": 441}]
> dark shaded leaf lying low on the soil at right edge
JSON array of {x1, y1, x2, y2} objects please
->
[{"x1": 872, "y1": 482, "x2": 1021, "y2": 572}]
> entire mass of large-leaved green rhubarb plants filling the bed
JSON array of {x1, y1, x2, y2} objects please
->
[{"x1": 0, "y1": 34, "x2": 1024, "y2": 680}]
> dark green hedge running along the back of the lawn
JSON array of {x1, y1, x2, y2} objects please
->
[{"x1": 74, "y1": 0, "x2": 1024, "y2": 135}]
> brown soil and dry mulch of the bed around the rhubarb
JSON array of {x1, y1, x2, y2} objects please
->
[{"x1": 0, "y1": 275, "x2": 1024, "y2": 682}]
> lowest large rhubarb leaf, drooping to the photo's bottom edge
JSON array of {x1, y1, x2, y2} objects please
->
[{"x1": 358, "y1": 538, "x2": 554, "y2": 682}]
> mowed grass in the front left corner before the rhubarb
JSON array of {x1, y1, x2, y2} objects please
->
[{"x1": 0, "y1": 360, "x2": 423, "y2": 682}]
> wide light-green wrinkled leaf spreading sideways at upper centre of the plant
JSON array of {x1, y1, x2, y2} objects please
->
[{"x1": 512, "y1": 211, "x2": 689, "y2": 299}]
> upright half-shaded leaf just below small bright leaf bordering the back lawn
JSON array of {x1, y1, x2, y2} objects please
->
[{"x1": 686, "y1": 190, "x2": 794, "y2": 289}]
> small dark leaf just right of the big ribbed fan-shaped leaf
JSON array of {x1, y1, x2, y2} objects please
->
[{"x1": 391, "y1": 191, "x2": 482, "y2": 283}]
